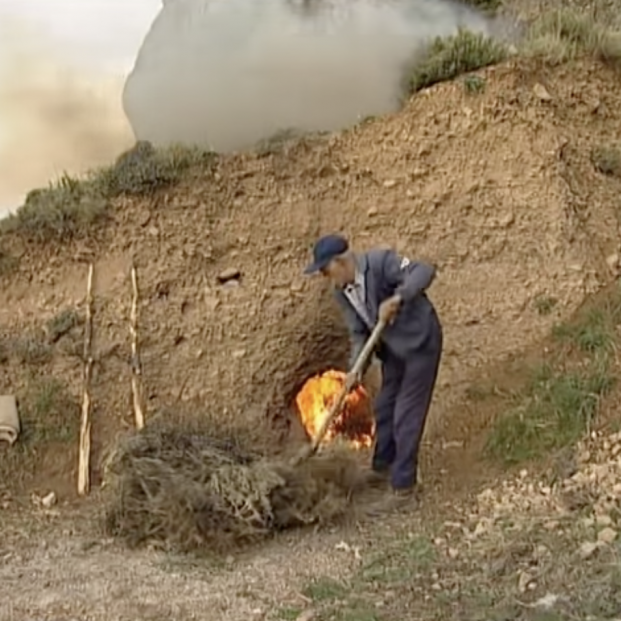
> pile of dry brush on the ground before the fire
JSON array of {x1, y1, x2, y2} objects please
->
[{"x1": 106, "y1": 428, "x2": 360, "y2": 552}]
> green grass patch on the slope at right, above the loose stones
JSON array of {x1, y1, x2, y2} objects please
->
[{"x1": 486, "y1": 287, "x2": 621, "y2": 465}]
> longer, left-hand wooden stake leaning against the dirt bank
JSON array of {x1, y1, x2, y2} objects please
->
[{"x1": 78, "y1": 263, "x2": 93, "y2": 496}]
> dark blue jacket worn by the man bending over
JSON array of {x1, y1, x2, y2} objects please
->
[{"x1": 334, "y1": 249, "x2": 441, "y2": 368}]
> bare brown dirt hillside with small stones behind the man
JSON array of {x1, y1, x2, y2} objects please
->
[{"x1": 0, "y1": 60, "x2": 621, "y2": 495}]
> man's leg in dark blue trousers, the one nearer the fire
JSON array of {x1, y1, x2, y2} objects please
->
[{"x1": 373, "y1": 354, "x2": 405, "y2": 472}]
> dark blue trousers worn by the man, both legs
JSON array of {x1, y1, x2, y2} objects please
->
[{"x1": 373, "y1": 331, "x2": 442, "y2": 489}]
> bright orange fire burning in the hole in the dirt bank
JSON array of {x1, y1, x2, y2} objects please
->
[{"x1": 295, "y1": 370, "x2": 375, "y2": 448}]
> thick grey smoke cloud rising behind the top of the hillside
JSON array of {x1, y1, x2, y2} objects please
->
[{"x1": 124, "y1": 0, "x2": 493, "y2": 151}]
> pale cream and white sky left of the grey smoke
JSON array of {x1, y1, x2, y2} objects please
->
[{"x1": 0, "y1": 0, "x2": 162, "y2": 215}]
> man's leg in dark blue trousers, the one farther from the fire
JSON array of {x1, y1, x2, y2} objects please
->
[{"x1": 391, "y1": 335, "x2": 442, "y2": 490}]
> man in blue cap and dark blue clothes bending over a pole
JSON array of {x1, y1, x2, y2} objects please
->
[{"x1": 305, "y1": 235, "x2": 442, "y2": 497}]
